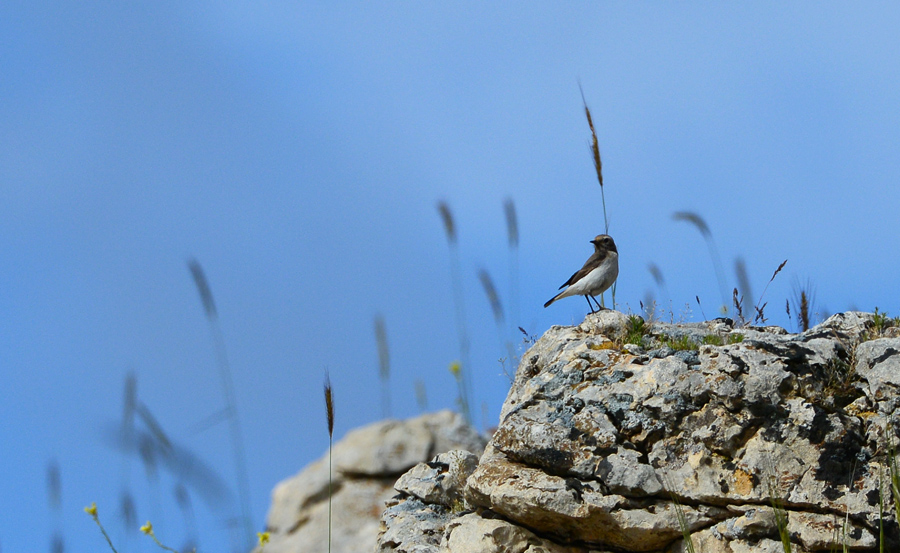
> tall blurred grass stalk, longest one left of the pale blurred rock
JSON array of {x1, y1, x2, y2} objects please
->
[{"x1": 188, "y1": 259, "x2": 253, "y2": 548}]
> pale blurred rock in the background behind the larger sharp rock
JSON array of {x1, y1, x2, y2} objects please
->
[{"x1": 265, "y1": 411, "x2": 484, "y2": 553}]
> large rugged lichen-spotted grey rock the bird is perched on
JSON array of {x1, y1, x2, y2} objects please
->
[{"x1": 377, "y1": 311, "x2": 900, "y2": 553}]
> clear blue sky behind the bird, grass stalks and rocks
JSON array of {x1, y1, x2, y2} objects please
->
[{"x1": 0, "y1": 1, "x2": 900, "y2": 551}]
